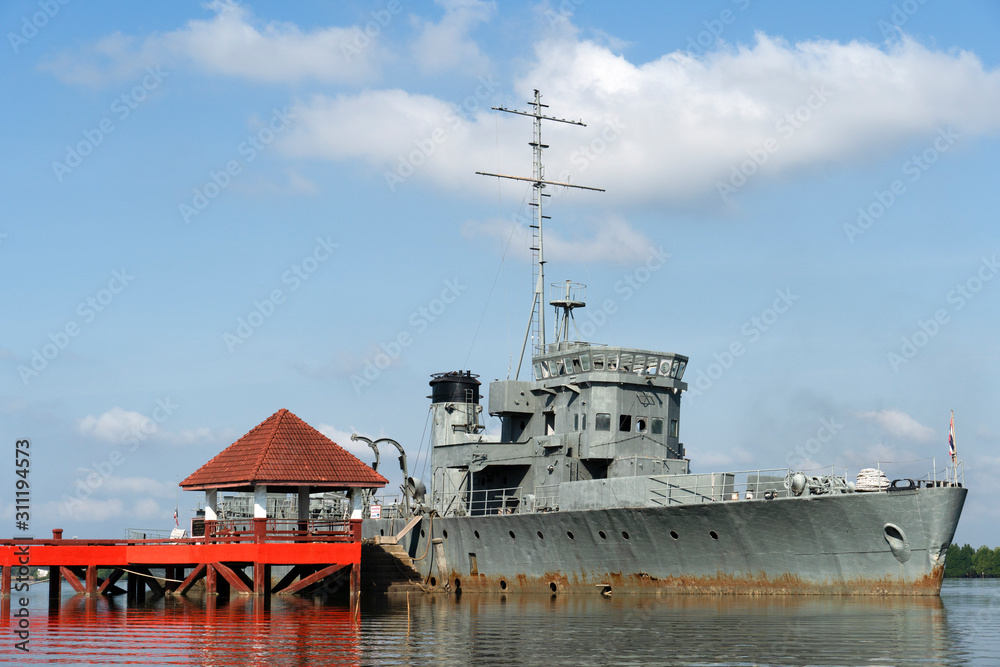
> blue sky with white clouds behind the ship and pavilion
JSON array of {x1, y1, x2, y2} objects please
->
[{"x1": 0, "y1": 0, "x2": 1000, "y2": 545}]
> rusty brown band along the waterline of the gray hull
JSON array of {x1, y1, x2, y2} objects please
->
[{"x1": 429, "y1": 564, "x2": 944, "y2": 596}]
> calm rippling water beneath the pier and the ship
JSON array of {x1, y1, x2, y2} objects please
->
[{"x1": 0, "y1": 580, "x2": 1000, "y2": 665}]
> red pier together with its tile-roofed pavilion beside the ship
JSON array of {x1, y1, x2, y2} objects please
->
[{"x1": 0, "y1": 410, "x2": 388, "y2": 606}]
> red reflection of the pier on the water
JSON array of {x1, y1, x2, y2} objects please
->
[{"x1": 20, "y1": 595, "x2": 359, "y2": 665}]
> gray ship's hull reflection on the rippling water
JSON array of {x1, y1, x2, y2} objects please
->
[{"x1": 362, "y1": 595, "x2": 952, "y2": 665}]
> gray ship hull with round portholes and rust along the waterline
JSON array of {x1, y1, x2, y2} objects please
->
[{"x1": 363, "y1": 487, "x2": 967, "y2": 595}]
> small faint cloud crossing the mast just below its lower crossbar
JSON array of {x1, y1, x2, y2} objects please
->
[{"x1": 462, "y1": 216, "x2": 654, "y2": 264}]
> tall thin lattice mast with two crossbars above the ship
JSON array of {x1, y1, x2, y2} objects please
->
[{"x1": 476, "y1": 90, "x2": 604, "y2": 380}]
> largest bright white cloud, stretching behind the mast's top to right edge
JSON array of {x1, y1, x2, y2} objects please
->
[{"x1": 281, "y1": 34, "x2": 1000, "y2": 205}]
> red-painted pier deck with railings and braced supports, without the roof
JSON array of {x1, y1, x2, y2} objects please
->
[{"x1": 0, "y1": 519, "x2": 361, "y2": 605}]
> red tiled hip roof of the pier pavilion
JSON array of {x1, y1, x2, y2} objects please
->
[{"x1": 181, "y1": 409, "x2": 389, "y2": 491}]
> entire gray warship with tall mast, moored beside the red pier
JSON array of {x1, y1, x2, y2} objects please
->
[{"x1": 363, "y1": 91, "x2": 967, "y2": 595}]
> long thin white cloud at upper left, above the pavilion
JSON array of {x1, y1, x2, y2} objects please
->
[{"x1": 41, "y1": 0, "x2": 386, "y2": 86}]
